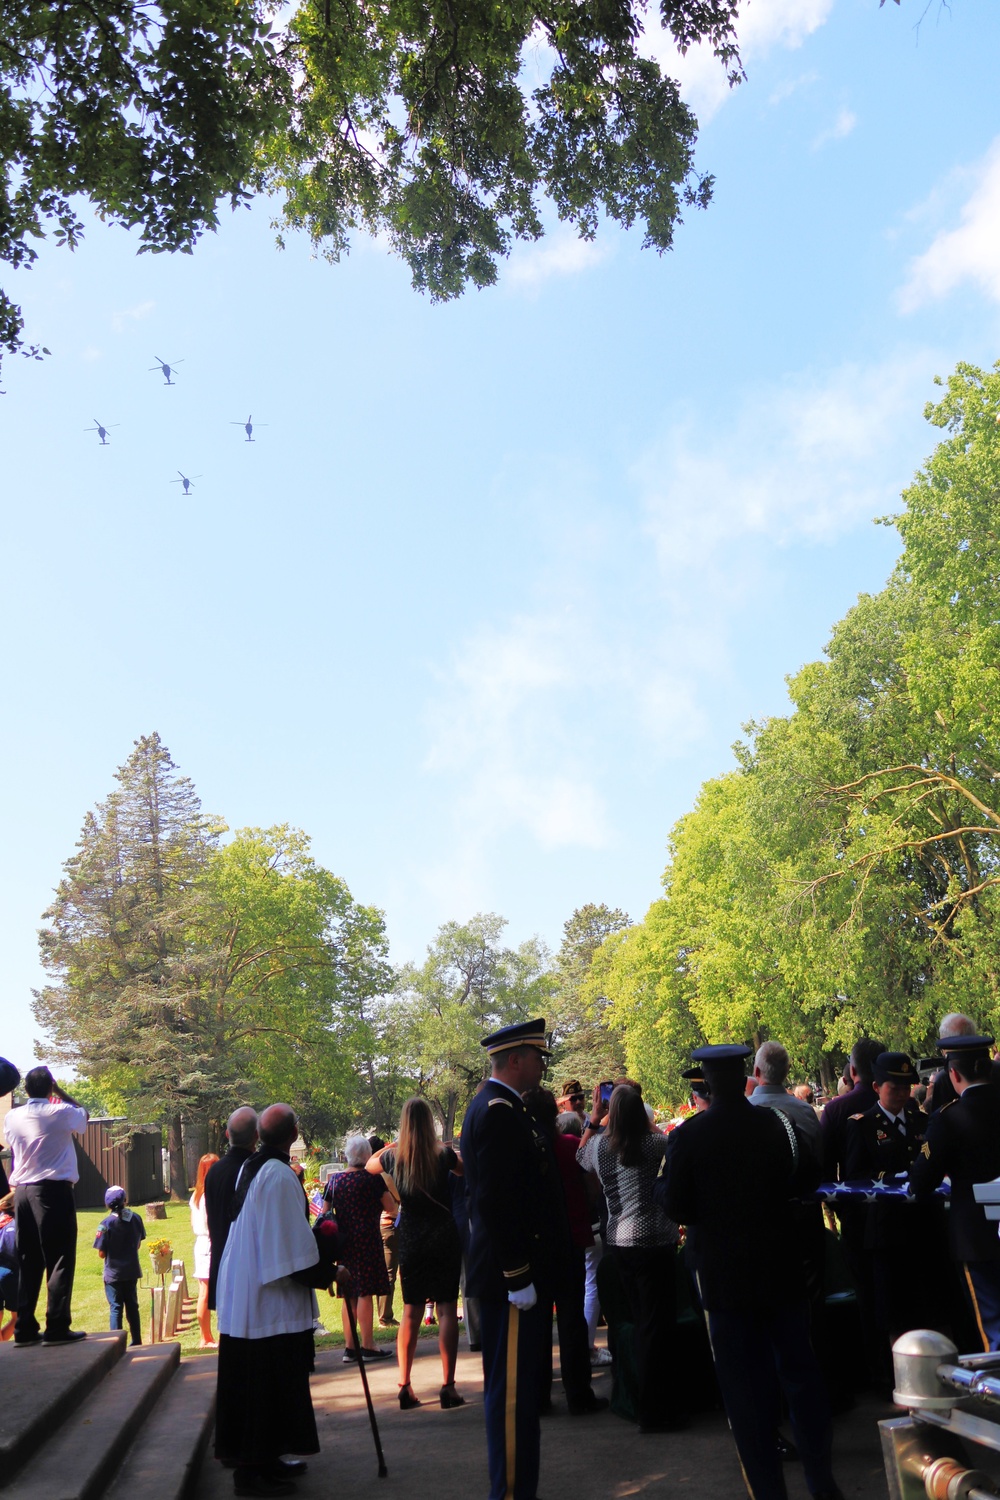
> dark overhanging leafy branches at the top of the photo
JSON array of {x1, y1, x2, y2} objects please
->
[{"x1": 0, "y1": 0, "x2": 741, "y2": 378}]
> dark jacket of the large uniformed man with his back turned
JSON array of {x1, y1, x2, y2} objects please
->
[{"x1": 654, "y1": 1097, "x2": 816, "y2": 1311}]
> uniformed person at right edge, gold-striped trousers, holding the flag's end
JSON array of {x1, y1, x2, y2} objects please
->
[{"x1": 910, "y1": 1037, "x2": 1000, "y2": 1352}]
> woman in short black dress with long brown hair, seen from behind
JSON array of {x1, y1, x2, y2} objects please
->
[{"x1": 367, "y1": 1100, "x2": 465, "y2": 1412}]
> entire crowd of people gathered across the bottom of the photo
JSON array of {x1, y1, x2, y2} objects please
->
[{"x1": 0, "y1": 1014, "x2": 1000, "y2": 1500}]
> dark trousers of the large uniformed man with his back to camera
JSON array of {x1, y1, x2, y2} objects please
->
[{"x1": 708, "y1": 1301, "x2": 837, "y2": 1500}]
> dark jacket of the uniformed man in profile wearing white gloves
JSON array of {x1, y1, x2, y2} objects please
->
[{"x1": 462, "y1": 1079, "x2": 568, "y2": 1301}]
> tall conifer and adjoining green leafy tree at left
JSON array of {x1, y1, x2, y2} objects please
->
[{"x1": 34, "y1": 735, "x2": 393, "y2": 1193}]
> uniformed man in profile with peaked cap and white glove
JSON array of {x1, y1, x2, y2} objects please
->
[{"x1": 462, "y1": 1020, "x2": 561, "y2": 1500}]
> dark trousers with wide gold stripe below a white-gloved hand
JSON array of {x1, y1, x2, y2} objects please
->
[{"x1": 480, "y1": 1298, "x2": 542, "y2": 1500}]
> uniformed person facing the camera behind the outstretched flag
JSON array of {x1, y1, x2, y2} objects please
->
[{"x1": 844, "y1": 1052, "x2": 948, "y2": 1383}]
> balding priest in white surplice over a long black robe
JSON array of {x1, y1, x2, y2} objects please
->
[{"x1": 216, "y1": 1104, "x2": 319, "y2": 1496}]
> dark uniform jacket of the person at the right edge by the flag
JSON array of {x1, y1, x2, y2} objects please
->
[{"x1": 910, "y1": 1083, "x2": 1000, "y2": 1262}]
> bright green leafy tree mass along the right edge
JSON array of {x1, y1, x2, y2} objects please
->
[{"x1": 602, "y1": 365, "x2": 1000, "y2": 1100}]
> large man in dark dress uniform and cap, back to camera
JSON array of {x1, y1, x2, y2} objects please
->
[{"x1": 654, "y1": 1047, "x2": 843, "y2": 1500}]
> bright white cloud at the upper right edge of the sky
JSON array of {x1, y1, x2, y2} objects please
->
[{"x1": 900, "y1": 138, "x2": 1000, "y2": 312}]
